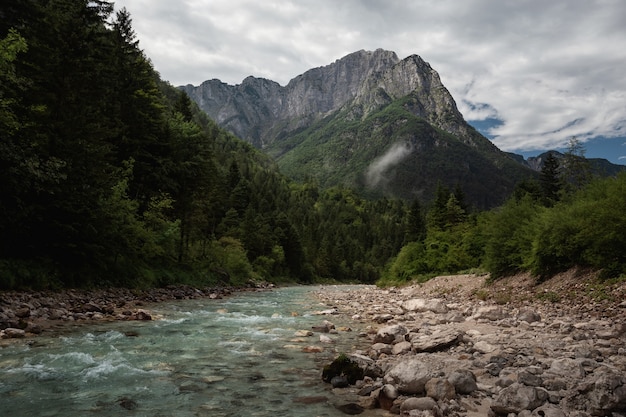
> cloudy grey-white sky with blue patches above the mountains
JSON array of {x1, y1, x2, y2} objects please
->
[{"x1": 115, "y1": 0, "x2": 626, "y2": 164}]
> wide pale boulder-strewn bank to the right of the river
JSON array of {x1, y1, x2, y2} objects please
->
[{"x1": 317, "y1": 271, "x2": 626, "y2": 417}]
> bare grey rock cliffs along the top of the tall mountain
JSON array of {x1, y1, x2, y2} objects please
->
[{"x1": 182, "y1": 49, "x2": 468, "y2": 148}]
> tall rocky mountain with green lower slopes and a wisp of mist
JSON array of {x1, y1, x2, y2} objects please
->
[{"x1": 181, "y1": 49, "x2": 536, "y2": 208}]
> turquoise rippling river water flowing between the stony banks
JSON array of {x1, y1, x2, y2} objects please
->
[{"x1": 0, "y1": 287, "x2": 372, "y2": 417}]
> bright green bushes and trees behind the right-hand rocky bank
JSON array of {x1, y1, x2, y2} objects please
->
[{"x1": 380, "y1": 138, "x2": 626, "y2": 285}]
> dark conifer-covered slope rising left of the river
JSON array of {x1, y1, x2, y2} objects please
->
[{"x1": 0, "y1": 0, "x2": 406, "y2": 288}]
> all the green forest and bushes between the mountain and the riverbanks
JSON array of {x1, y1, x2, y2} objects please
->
[{"x1": 0, "y1": 0, "x2": 626, "y2": 289}]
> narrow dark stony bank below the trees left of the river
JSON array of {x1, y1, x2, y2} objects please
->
[{"x1": 0, "y1": 285, "x2": 269, "y2": 339}]
